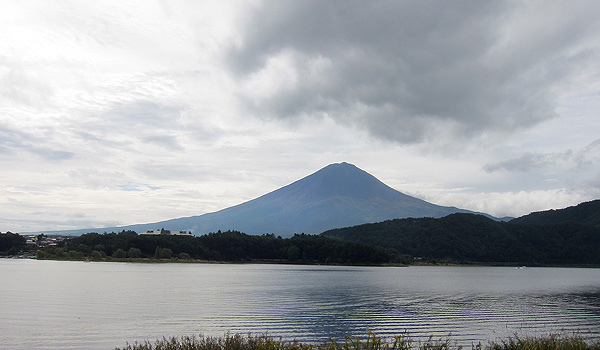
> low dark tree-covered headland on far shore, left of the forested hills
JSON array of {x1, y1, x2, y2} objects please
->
[{"x1": 38, "y1": 231, "x2": 394, "y2": 264}]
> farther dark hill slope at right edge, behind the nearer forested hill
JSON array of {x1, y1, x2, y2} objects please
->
[{"x1": 510, "y1": 199, "x2": 600, "y2": 227}]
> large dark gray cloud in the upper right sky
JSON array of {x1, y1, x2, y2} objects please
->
[{"x1": 229, "y1": 1, "x2": 600, "y2": 143}]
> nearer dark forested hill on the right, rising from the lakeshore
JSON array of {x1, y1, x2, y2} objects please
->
[{"x1": 323, "y1": 214, "x2": 600, "y2": 265}]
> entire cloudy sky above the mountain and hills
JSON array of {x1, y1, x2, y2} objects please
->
[{"x1": 0, "y1": 0, "x2": 600, "y2": 232}]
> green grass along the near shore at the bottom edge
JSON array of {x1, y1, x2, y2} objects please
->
[{"x1": 115, "y1": 333, "x2": 600, "y2": 350}]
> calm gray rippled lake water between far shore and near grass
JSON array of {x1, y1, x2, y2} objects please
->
[{"x1": 0, "y1": 259, "x2": 600, "y2": 349}]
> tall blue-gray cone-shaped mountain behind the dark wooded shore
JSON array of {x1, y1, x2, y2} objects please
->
[{"x1": 51, "y1": 163, "x2": 494, "y2": 237}]
